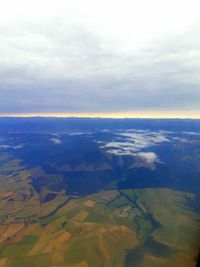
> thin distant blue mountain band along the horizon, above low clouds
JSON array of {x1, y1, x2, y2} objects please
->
[{"x1": 0, "y1": 117, "x2": 200, "y2": 133}]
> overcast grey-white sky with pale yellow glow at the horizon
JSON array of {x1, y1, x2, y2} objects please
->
[{"x1": 0, "y1": 0, "x2": 200, "y2": 118}]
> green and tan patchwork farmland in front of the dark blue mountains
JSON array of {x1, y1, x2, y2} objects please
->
[{"x1": 0, "y1": 155, "x2": 200, "y2": 267}]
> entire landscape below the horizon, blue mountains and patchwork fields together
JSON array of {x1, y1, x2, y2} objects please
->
[{"x1": 0, "y1": 118, "x2": 200, "y2": 267}]
